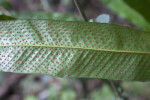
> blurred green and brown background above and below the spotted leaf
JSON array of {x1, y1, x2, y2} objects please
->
[{"x1": 0, "y1": 0, "x2": 150, "y2": 100}]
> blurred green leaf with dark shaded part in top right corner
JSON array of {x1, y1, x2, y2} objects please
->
[{"x1": 102, "y1": 0, "x2": 150, "y2": 31}]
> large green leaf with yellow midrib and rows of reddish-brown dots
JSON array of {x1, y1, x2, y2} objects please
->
[{"x1": 0, "y1": 20, "x2": 150, "y2": 81}]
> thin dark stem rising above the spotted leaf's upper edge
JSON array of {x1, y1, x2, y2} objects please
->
[{"x1": 74, "y1": 0, "x2": 88, "y2": 22}]
